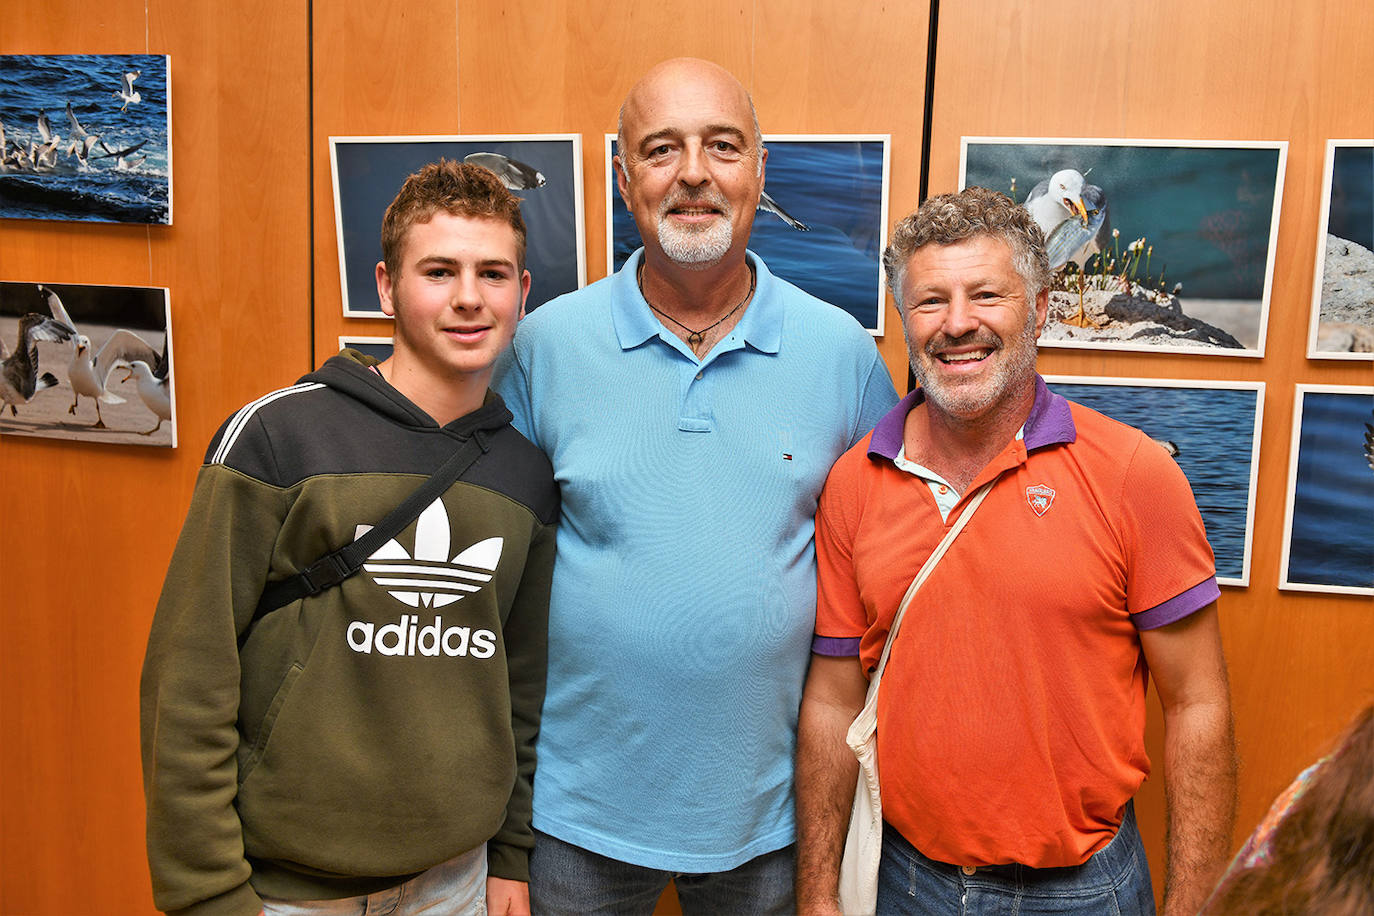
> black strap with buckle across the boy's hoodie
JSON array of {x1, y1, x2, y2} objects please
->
[{"x1": 243, "y1": 430, "x2": 491, "y2": 637}]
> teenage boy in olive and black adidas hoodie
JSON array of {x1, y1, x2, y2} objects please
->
[{"x1": 142, "y1": 161, "x2": 558, "y2": 915}]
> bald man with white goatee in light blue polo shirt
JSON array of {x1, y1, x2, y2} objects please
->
[{"x1": 496, "y1": 59, "x2": 896, "y2": 916}]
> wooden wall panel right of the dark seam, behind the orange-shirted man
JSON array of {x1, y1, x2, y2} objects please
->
[{"x1": 930, "y1": 0, "x2": 1374, "y2": 893}]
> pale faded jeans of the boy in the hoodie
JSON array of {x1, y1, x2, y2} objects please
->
[{"x1": 262, "y1": 843, "x2": 486, "y2": 916}]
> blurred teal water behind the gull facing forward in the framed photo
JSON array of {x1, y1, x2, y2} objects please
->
[{"x1": 965, "y1": 141, "x2": 1279, "y2": 301}]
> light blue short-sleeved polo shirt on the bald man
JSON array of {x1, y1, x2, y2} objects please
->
[{"x1": 493, "y1": 251, "x2": 897, "y2": 872}]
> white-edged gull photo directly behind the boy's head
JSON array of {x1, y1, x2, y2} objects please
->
[{"x1": 338, "y1": 133, "x2": 587, "y2": 319}]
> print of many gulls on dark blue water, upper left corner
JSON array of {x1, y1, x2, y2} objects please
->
[{"x1": 0, "y1": 54, "x2": 172, "y2": 224}]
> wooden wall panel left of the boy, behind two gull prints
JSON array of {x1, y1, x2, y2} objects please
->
[{"x1": 0, "y1": 0, "x2": 311, "y2": 916}]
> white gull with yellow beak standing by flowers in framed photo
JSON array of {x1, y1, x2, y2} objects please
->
[{"x1": 1025, "y1": 169, "x2": 1112, "y2": 328}]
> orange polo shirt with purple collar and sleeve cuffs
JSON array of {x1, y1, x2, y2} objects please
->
[{"x1": 813, "y1": 378, "x2": 1219, "y2": 868}]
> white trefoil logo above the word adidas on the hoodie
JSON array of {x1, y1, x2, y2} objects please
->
[{"x1": 353, "y1": 499, "x2": 504, "y2": 607}]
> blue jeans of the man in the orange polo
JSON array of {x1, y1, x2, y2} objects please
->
[{"x1": 878, "y1": 803, "x2": 1154, "y2": 916}]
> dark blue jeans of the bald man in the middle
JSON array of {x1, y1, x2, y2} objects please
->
[{"x1": 529, "y1": 831, "x2": 797, "y2": 916}]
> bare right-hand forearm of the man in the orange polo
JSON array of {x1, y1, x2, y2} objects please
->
[{"x1": 1164, "y1": 698, "x2": 1235, "y2": 916}]
